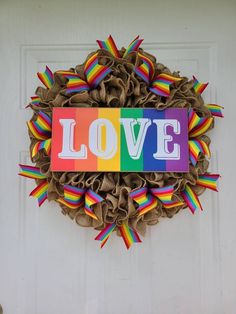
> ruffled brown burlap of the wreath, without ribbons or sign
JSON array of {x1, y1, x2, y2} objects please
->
[{"x1": 29, "y1": 48, "x2": 213, "y2": 235}]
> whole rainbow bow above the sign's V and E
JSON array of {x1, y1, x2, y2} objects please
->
[{"x1": 134, "y1": 53, "x2": 182, "y2": 97}]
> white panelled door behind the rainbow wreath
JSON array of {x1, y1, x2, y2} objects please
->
[{"x1": 0, "y1": 0, "x2": 236, "y2": 314}]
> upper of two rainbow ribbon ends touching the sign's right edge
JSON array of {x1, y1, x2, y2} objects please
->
[{"x1": 188, "y1": 108, "x2": 213, "y2": 138}]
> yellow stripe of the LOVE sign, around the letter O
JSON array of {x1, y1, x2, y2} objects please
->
[{"x1": 97, "y1": 108, "x2": 120, "y2": 171}]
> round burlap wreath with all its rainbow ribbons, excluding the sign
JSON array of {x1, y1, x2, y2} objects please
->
[{"x1": 19, "y1": 36, "x2": 223, "y2": 248}]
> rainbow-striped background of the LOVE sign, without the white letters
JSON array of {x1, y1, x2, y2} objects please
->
[{"x1": 51, "y1": 108, "x2": 189, "y2": 172}]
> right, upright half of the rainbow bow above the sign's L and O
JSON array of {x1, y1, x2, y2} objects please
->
[{"x1": 84, "y1": 52, "x2": 111, "y2": 88}]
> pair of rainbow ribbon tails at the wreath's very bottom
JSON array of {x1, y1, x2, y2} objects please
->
[{"x1": 95, "y1": 223, "x2": 142, "y2": 249}]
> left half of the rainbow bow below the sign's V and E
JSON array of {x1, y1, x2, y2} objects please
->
[{"x1": 129, "y1": 188, "x2": 158, "y2": 216}]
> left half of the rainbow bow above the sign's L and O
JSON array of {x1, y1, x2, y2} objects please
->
[{"x1": 57, "y1": 71, "x2": 89, "y2": 94}]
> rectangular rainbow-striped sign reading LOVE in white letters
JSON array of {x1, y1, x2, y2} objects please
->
[{"x1": 51, "y1": 108, "x2": 189, "y2": 172}]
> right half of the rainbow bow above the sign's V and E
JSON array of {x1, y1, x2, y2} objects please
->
[{"x1": 149, "y1": 73, "x2": 182, "y2": 97}]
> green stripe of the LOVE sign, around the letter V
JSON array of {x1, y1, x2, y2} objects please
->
[{"x1": 120, "y1": 108, "x2": 143, "y2": 171}]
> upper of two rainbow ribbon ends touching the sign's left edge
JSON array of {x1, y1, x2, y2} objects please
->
[{"x1": 27, "y1": 111, "x2": 52, "y2": 140}]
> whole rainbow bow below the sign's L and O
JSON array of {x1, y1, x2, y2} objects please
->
[{"x1": 58, "y1": 184, "x2": 103, "y2": 220}]
